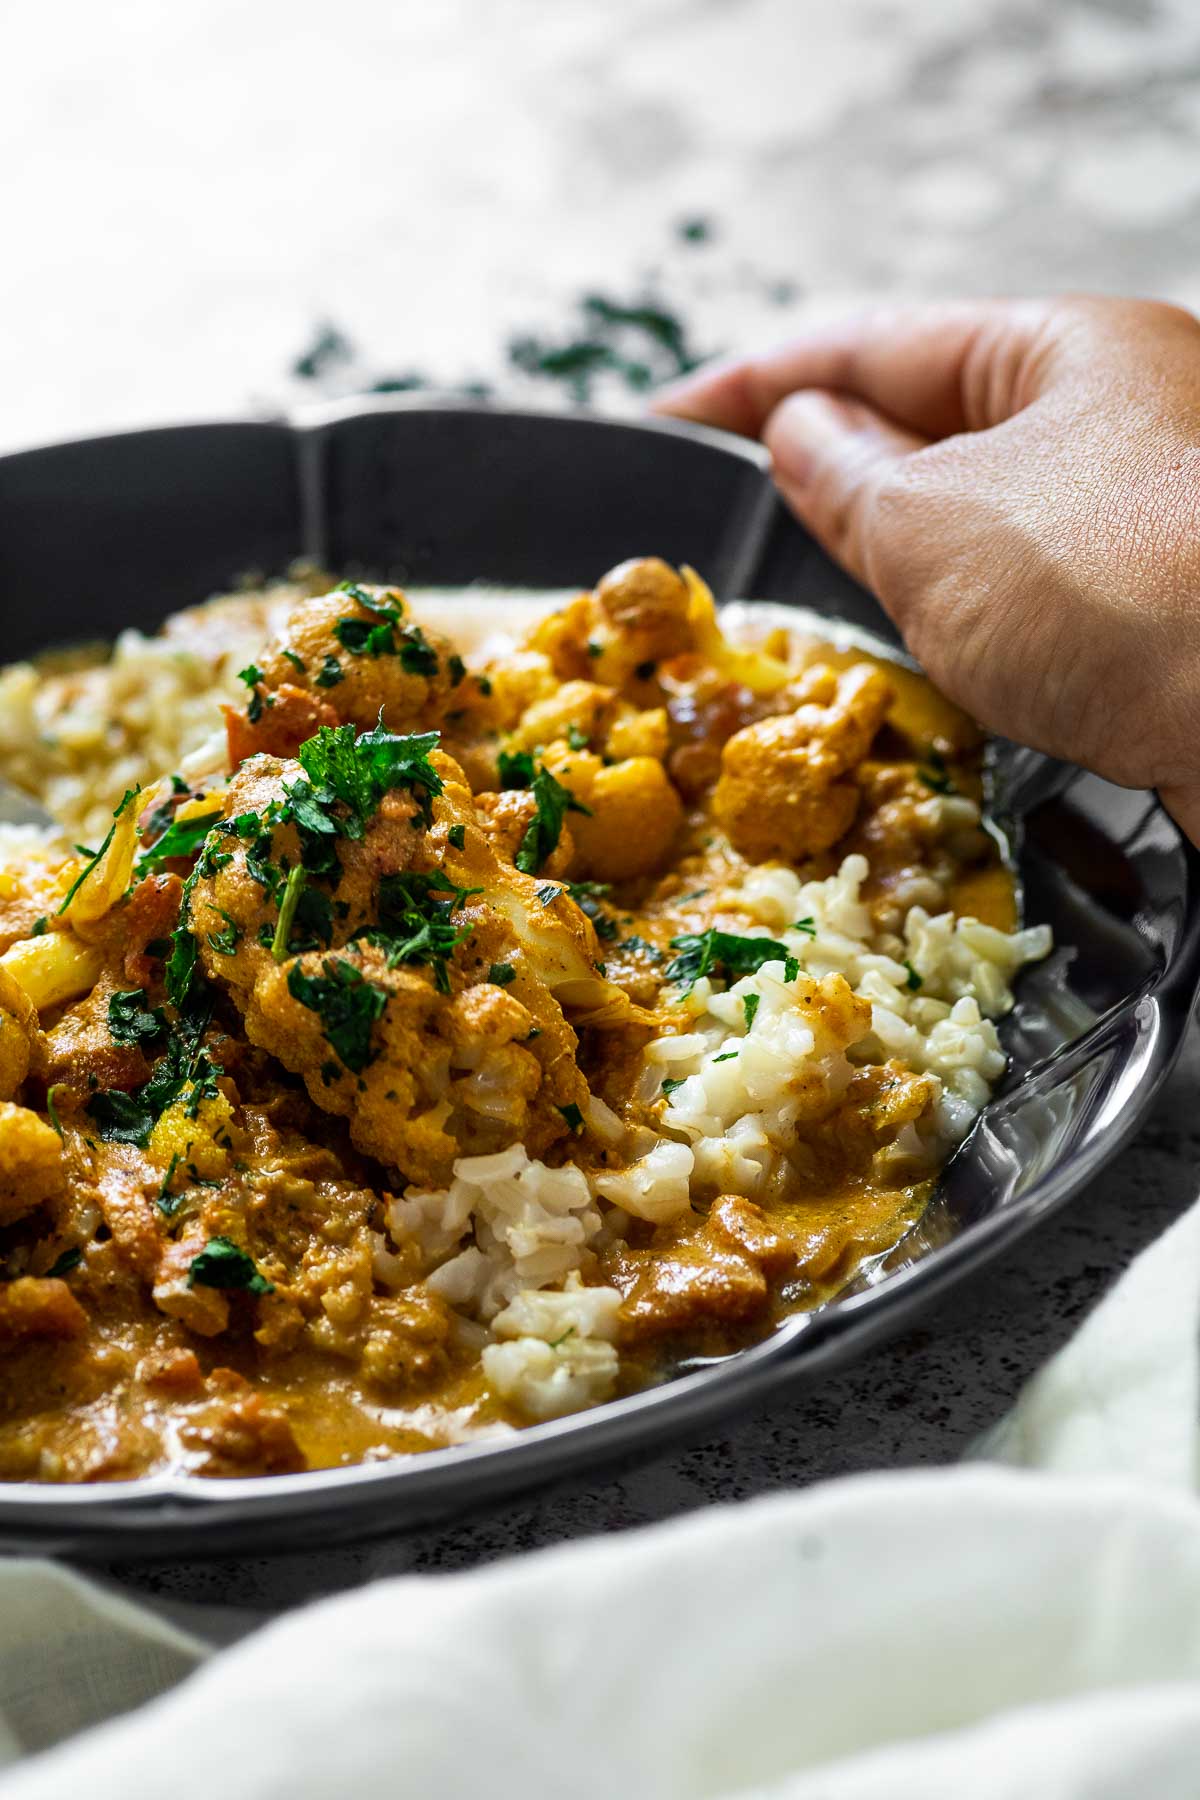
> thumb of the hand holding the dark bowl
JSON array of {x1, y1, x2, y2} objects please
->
[{"x1": 763, "y1": 389, "x2": 928, "y2": 587}]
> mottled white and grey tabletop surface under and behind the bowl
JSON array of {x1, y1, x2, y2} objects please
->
[{"x1": 0, "y1": 0, "x2": 1200, "y2": 1606}]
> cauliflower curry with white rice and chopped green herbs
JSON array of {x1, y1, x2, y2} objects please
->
[{"x1": 0, "y1": 558, "x2": 1047, "y2": 1481}]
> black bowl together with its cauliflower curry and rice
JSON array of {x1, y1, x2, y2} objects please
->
[{"x1": 0, "y1": 401, "x2": 1198, "y2": 1557}]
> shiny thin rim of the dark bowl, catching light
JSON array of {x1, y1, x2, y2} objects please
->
[{"x1": 0, "y1": 392, "x2": 1200, "y2": 1561}]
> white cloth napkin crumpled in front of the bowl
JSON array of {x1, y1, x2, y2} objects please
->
[{"x1": 0, "y1": 1180, "x2": 1200, "y2": 1800}]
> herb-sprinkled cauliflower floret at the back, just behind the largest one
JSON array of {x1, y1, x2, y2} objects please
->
[{"x1": 251, "y1": 583, "x2": 467, "y2": 742}]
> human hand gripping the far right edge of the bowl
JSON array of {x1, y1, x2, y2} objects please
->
[{"x1": 655, "y1": 299, "x2": 1200, "y2": 844}]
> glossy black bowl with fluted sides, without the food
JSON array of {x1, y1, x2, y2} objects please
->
[{"x1": 0, "y1": 398, "x2": 1200, "y2": 1561}]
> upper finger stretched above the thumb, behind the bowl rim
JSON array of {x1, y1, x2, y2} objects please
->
[{"x1": 655, "y1": 301, "x2": 1049, "y2": 437}]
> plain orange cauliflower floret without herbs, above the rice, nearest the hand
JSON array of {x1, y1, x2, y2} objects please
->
[{"x1": 712, "y1": 662, "x2": 892, "y2": 862}]
